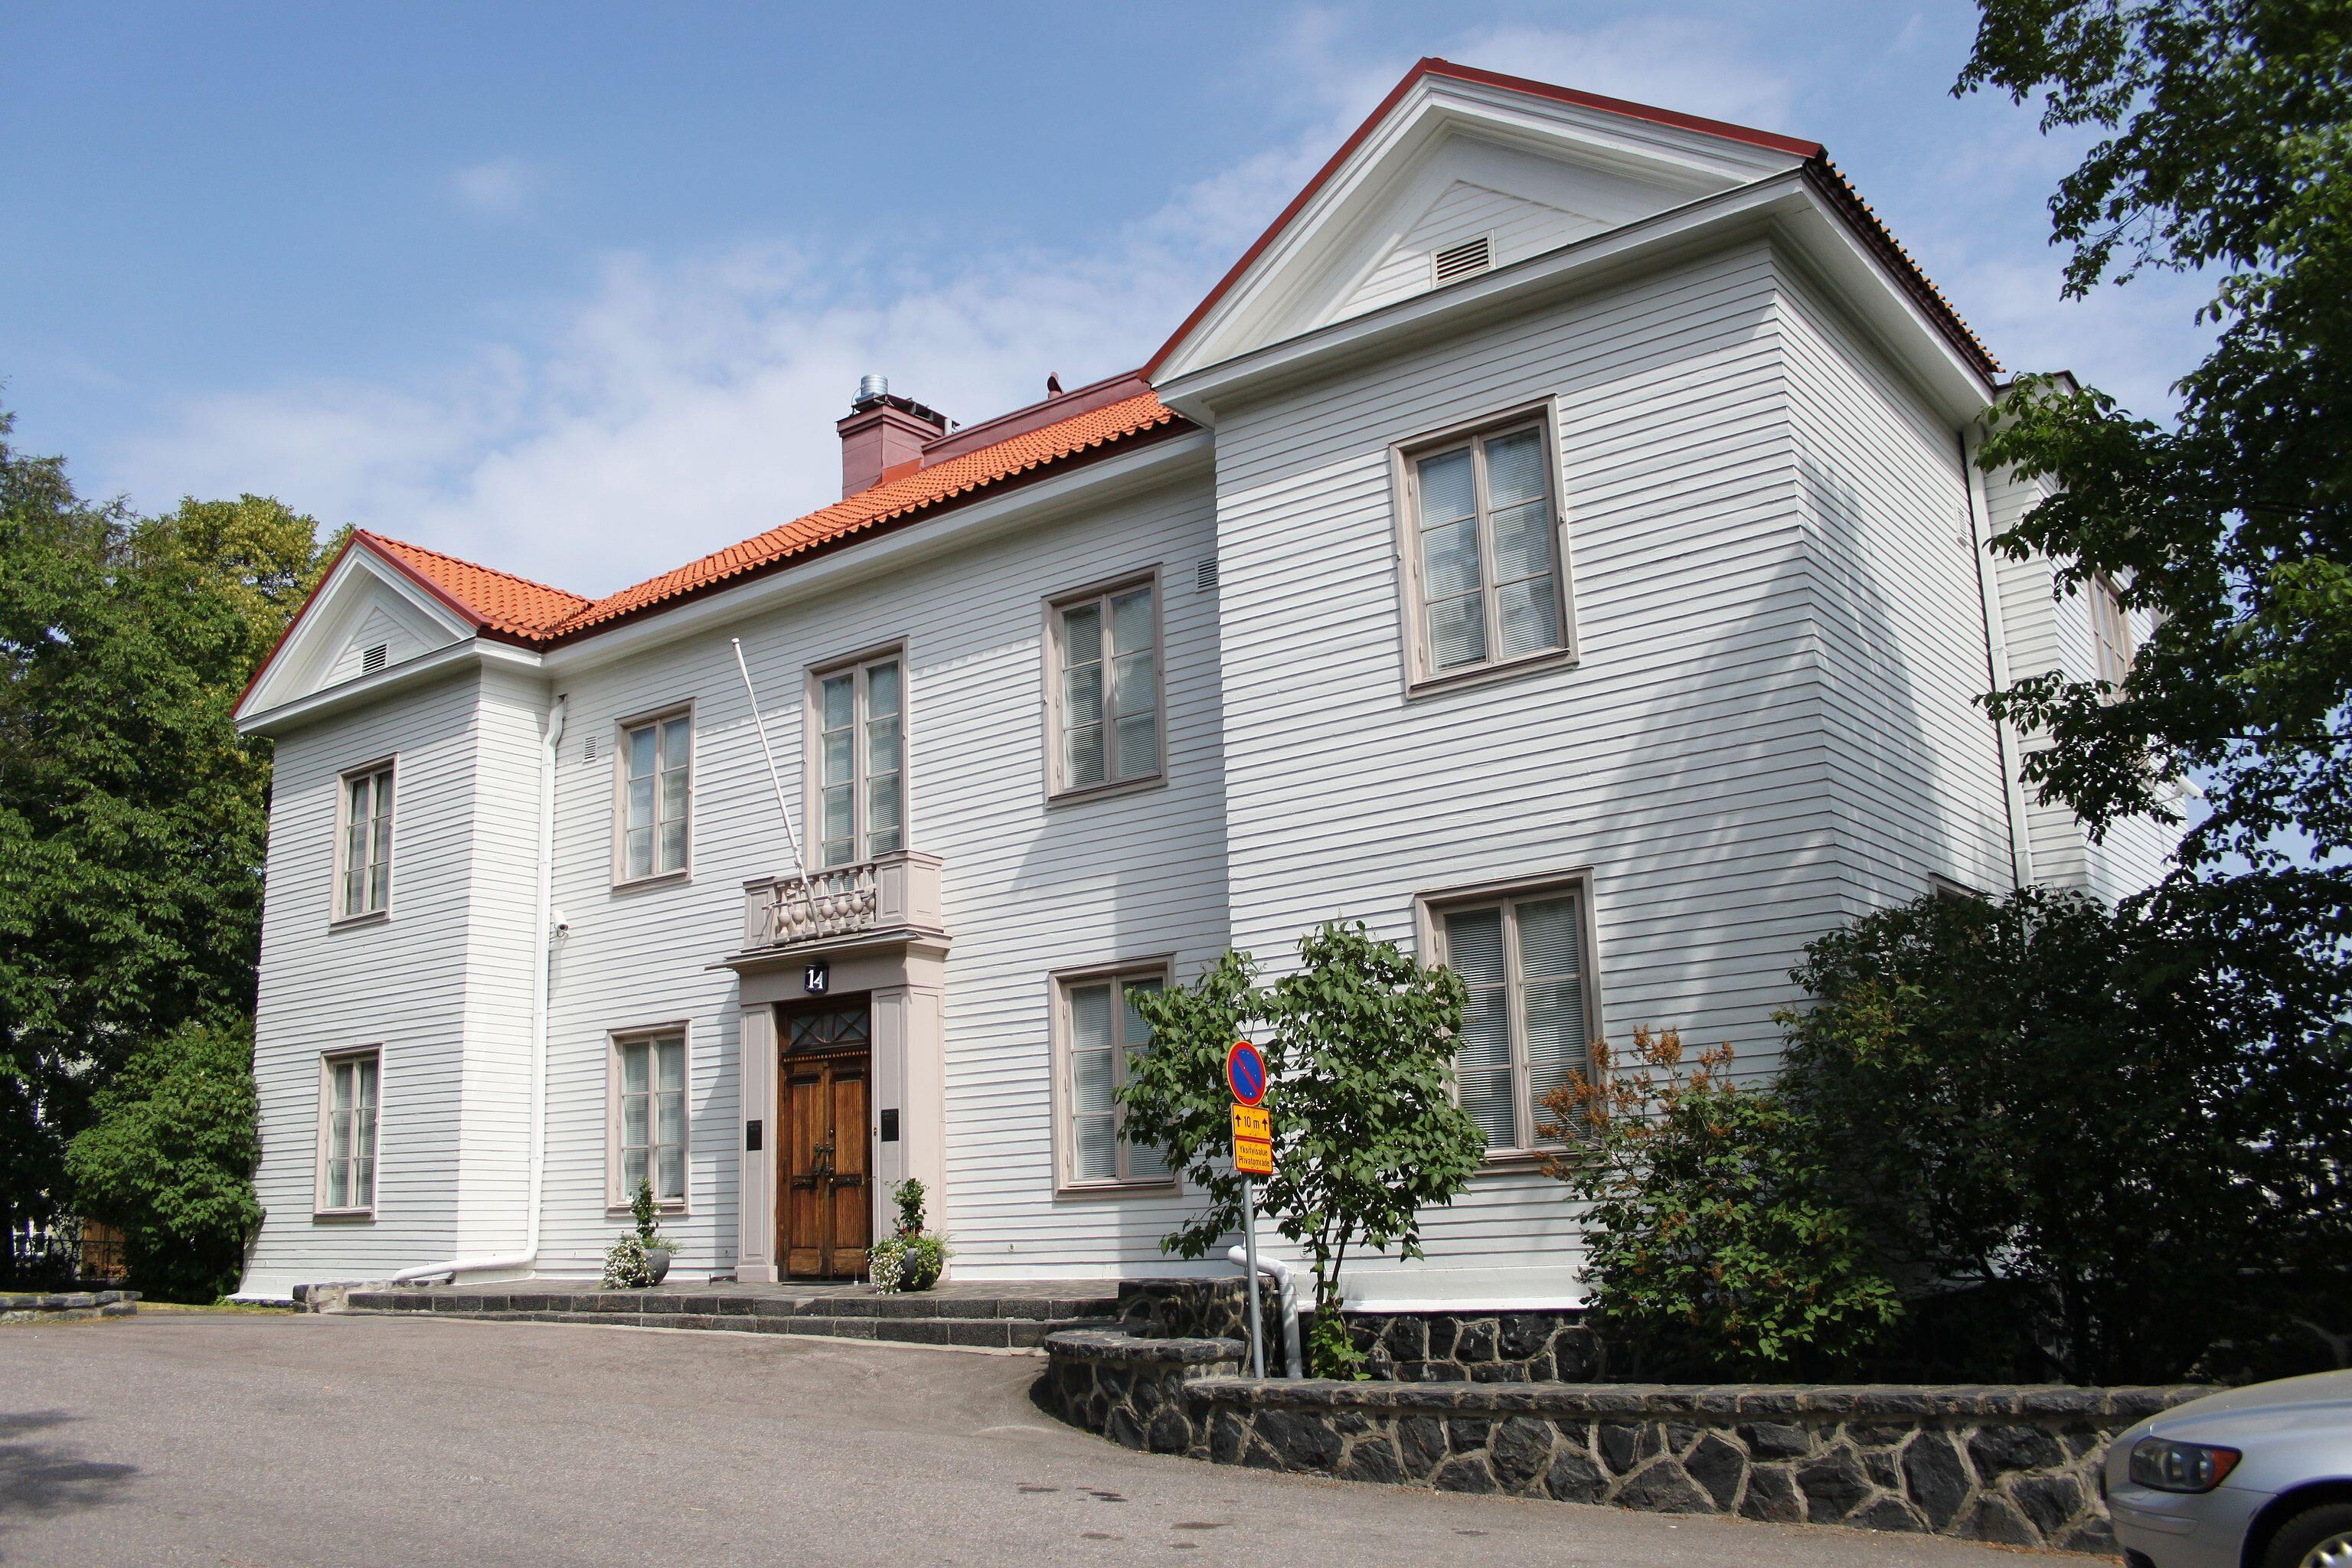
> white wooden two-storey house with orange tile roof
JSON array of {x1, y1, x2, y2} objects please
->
[{"x1": 240, "y1": 61, "x2": 2166, "y2": 1302}]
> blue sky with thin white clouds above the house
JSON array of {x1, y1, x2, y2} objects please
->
[{"x1": 0, "y1": 2, "x2": 2199, "y2": 593}]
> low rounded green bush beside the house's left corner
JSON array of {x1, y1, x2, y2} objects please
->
[{"x1": 66, "y1": 1023, "x2": 261, "y2": 1302}]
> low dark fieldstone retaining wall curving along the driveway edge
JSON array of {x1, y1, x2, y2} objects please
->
[{"x1": 1040, "y1": 1331, "x2": 2209, "y2": 1554}]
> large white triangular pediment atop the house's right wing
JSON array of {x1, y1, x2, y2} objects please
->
[{"x1": 1150, "y1": 61, "x2": 1818, "y2": 386}]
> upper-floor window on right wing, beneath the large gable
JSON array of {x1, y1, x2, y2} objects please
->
[{"x1": 1397, "y1": 413, "x2": 1573, "y2": 684}]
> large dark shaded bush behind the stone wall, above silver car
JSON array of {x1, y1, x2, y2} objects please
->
[{"x1": 1783, "y1": 889, "x2": 2352, "y2": 1382}]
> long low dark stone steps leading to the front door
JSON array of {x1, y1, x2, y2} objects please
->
[{"x1": 334, "y1": 1286, "x2": 1117, "y2": 1349}]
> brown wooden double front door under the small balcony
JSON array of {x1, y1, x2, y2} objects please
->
[{"x1": 776, "y1": 997, "x2": 873, "y2": 1279}]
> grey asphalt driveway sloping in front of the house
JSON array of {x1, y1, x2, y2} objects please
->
[{"x1": 0, "y1": 1316, "x2": 2041, "y2": 1568}]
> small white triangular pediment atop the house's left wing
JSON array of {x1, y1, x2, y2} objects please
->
[{"x1": 237, "y1": 543, "x2": 475, "y2": 714}]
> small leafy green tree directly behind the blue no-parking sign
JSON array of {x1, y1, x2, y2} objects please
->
[{"x1": 1119, "y1": 922, "x2": 1487, "y2": 1377}]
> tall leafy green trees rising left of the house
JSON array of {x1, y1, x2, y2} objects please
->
[{"x1": 0, "y1": 411, "x2": 334, "y2": 1279}]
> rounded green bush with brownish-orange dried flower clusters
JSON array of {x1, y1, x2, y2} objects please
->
[{"x1": 1540, "y1": 1027, "x2": 1903, "y2": 1377}]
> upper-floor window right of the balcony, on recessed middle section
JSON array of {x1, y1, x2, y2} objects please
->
[{"x1": 1047, "y1": 576, "x2": 1167, "y2": 795}]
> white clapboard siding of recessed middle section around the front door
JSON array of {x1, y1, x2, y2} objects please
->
[{"x1": 544, "y1": 470, "x2": 1226, "y2": 1279}]
